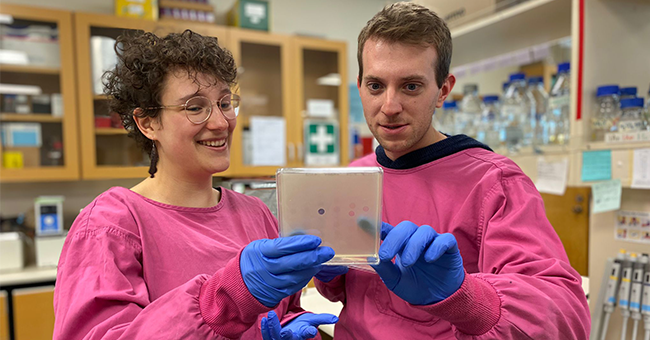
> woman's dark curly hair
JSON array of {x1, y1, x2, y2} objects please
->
[{"x1": 103, "y1": 30, "x2": 237, "y2": 177}]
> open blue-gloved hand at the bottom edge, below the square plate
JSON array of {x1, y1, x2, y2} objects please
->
[{"x1": 262, "y1": 311, "x2": 339, "y2": 340}]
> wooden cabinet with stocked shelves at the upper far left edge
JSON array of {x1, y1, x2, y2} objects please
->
[{"x1": 0, "y1": 4, "x2": 79, "y2": 182}]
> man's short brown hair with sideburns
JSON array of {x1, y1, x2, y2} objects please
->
[{"x1": 357, "y1": 2, "x2": 452, "y2": 87}]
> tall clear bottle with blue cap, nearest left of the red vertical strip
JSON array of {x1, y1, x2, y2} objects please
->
[{"x1": 547, "y1": 63, "x2": 571, "y2": 145}]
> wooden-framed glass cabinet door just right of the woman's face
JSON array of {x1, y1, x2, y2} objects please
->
[{"x1": 229, "y1": 28, "x2": 297, "y2": 177}]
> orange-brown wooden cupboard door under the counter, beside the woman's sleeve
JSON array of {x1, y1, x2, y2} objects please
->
[{"x1": 12, "y1": 286, "x2": 54, "y2": 340}]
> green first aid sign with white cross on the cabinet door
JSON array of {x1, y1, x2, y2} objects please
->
[{"x1": 304, "y1": 120, "x2": 339, "y2": 165}]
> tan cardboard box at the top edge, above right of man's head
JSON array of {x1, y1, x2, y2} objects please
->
[{"x1": 416, "y1": 0, "x2": 497, "y2": 28}]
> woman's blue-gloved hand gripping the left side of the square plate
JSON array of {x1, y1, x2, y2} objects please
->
[{"x1": 239, "y1": 235, "x2": 334, "y2": 307}]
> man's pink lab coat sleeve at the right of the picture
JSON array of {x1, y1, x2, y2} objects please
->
[{"x1": 414, "y1": 177, "x2": 590, "y2": 339}]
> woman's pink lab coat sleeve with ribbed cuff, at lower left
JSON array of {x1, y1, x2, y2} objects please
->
[{"x1": 53, "y1": 227, "x2": 270, "y2": 340}]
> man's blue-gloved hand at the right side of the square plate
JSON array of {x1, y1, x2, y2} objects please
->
[{"x1": 372, "y1": 221, "x2": 465, "y2": 305}]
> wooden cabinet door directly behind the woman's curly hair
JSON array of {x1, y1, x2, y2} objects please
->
[{"x1": 74, "y1": 13, "x2": 232, "y2": 179}]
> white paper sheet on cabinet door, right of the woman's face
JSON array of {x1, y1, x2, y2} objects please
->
[{"x1": 250, "y1": 116, "x2": 287, "y2": 166}]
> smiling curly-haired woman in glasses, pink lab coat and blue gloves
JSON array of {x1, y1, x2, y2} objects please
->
[{"x1": 54, "y1": 31, "x2": 335, "y2": 339}]
